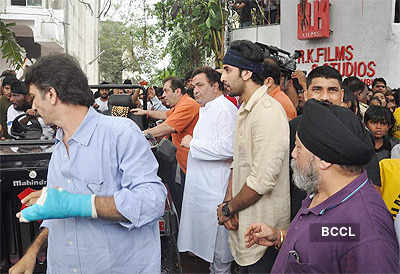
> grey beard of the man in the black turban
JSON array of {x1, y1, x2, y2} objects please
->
[{"x1": 290, "y1": 159, "x2": 320, "y2": 194}]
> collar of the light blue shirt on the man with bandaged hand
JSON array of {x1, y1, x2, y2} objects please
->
[{"x1": 56, "y1": 107, "x2": 102, "y2": 146}]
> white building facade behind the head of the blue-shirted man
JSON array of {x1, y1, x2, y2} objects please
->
[{"x1": 0, "y1": 0, "x2": 100, "y2": 84}]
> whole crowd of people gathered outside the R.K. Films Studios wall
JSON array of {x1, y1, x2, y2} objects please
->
[{"x1": 0, "y1": 40, "x2": 400, "y2": 273}]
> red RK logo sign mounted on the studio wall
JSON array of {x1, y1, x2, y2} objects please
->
[{"x1": 297, "y1": 0, "x2": 329, "y2": 40}]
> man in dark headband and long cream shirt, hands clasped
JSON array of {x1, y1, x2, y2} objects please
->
[{"x1": 217, "y1": 40, "x2": 290, "y2": 273}]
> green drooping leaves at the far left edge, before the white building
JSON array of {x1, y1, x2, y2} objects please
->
[{"x1": 0, "y1": 19, "x2": 24, "y2": 69}]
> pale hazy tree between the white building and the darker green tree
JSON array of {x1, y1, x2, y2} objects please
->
[{"x1": 99, "y1": 0, "x2": 164, "y2": 83}]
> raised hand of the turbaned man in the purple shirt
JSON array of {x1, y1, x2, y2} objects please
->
[{"x1": 244, "y1": 224, "x2": 280, "y2": 248}]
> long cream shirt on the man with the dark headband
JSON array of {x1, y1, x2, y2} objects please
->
[{"x1": 229, "y1": 86, "x2": 290, "y2": 266}]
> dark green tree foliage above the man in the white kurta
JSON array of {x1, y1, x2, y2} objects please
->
[{"x1": 154, "y1": 0, "x2": 225, "y2": 77}]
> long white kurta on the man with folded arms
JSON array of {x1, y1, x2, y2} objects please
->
[{"x1": 178, "y1": 96, "x2": 237, "y2": 262}]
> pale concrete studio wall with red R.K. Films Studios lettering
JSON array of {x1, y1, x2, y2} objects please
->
[{"x1": 232, "y1": 0, "x2": 400, "y2": 88}]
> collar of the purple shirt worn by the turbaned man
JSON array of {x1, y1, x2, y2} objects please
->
[{"x1": 300, "y1": 171, "x2": 368, "y2": 215}]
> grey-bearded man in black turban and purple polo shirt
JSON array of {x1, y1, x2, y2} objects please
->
[{"x1": 246, "y1": 99, "x2": 399, "y2": 273}]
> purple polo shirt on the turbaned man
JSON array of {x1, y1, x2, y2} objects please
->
[{"x1": 271, "y1": 172, "x2": 400, "y2": 273}]
